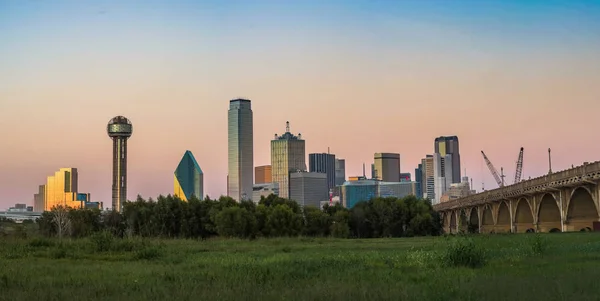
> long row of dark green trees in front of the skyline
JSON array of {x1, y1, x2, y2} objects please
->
[{"x1": 37, "y1": 195, "x2": 442, "y2": 239}]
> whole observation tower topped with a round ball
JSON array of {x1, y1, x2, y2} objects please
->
[{"x1": 107, "y1": 116, "x2": 133, "y2": 212}]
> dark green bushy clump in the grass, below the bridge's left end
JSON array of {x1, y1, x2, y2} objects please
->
[{"x1": 441, "y1": 238, "x2": 486, "y2": 268}]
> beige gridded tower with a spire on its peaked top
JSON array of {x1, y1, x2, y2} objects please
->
[{"x1": 271, "y1": 121, "x2": 306, "y2": 198}]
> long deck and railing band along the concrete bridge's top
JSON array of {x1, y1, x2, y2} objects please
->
[{"x1": 433, "y1": 161, "x2": 600, "y2": 211}]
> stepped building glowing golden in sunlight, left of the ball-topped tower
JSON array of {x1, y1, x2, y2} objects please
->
[{"x1": 44, "y1": 168, "x2": 81, "y2": 211}]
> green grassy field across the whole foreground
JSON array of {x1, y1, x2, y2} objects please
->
[{"x1": 0, "y1": 233, "x2": 600, "y2": 301}]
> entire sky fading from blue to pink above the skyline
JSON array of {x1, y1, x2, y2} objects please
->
[{"x1": 0, "y1": 0, "x2": 600, "y2": 209}]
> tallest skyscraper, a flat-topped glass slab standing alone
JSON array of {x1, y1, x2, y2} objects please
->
[{"x1": 227, "y1": 99, "x2": 254, "y2": 201}]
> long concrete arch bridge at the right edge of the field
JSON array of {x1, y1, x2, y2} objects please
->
[{"x1": 433, "y1": 161, "x2": 600, "y2": 233}]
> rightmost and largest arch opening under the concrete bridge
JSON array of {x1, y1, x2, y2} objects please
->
[{"x1": 566, "y1": 187, "x2": 598, "y2": 231}]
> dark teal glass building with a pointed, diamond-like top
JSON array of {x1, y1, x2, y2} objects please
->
[{"x1": 173, "y1": 150, "x2": 204, "y2": 201}]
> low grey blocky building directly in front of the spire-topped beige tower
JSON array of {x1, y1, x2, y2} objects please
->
[{"x1": 290, "y1": 172, "x2": 329, "y2": 207}]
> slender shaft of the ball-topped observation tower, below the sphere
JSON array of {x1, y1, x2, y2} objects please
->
[{"x1": 112, "y1": 137, "x2": 127, "y2": 212}]
